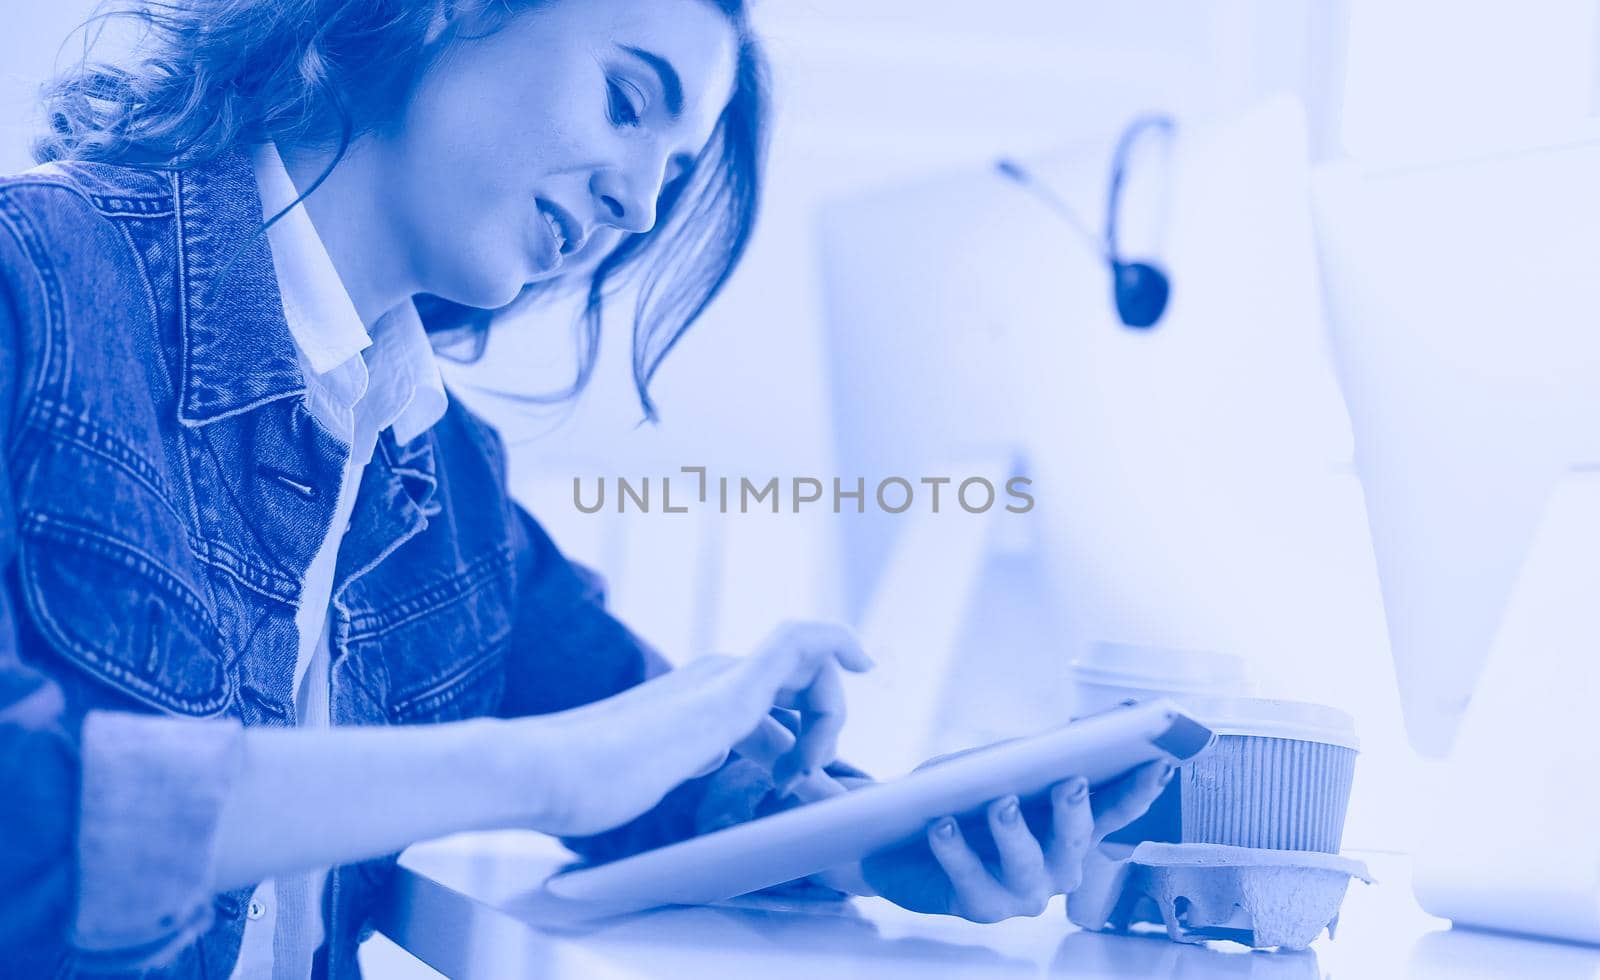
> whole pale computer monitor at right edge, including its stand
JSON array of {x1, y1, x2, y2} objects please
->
[{"x1": 1314, "y1": 131, "x2": 1600, "y2": 943}]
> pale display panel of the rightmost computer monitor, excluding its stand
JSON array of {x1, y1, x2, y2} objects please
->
[{"x1": 1314, "y1": 138, "x2": 1600, "y2": 756}]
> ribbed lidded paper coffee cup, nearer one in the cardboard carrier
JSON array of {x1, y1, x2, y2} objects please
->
[{"x1": 1181, "y1": 698, "x2": 1360, "y2": 853}]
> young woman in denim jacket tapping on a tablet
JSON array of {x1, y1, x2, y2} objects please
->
[{"x1": 0, "y1": 0, "x2": 1170, "y2": 977}]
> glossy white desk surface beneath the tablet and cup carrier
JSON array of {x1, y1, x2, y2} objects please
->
[{"x1": 371, "y1": 834, "x2": 1600, "y2": 980}]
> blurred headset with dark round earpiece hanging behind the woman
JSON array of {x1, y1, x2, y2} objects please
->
[{"x1": 995, "y1": 114, "x2": 1176, "y2": 330}]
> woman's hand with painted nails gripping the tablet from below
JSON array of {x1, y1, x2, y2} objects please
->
[{"x1": 861, "y1": 762, "x2": 1174, "y2": 922}]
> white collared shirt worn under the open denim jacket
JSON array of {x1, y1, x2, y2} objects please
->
[{"x1": 234, "y1": 144, "x2": 446, "y2": 980}]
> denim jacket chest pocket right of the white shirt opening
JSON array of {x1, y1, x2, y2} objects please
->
[{"x1": 347, "y1": 551, "x2": 514, "y2": 724}]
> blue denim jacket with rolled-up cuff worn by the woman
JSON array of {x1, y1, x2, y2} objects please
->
[{"x1": 0, "y1": 152, "x2": 800, "y2": 977}]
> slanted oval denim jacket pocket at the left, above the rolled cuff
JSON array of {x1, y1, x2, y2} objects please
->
[{"x1": 18, "y1": 511, "x2": 230, "y2": 716}]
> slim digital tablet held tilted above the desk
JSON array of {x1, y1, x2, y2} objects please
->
[{"x1": 546, "y1": 700, "x2": 1211, "y2": 914}]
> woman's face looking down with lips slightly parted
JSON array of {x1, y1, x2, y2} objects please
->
[{"x1": 371, "y1": 0, "x2": 736, "y2": 307}]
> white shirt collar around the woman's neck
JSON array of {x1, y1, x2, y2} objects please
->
[{"x1": 253, "y1": 143, "x2": 448, "y2": 444}]
